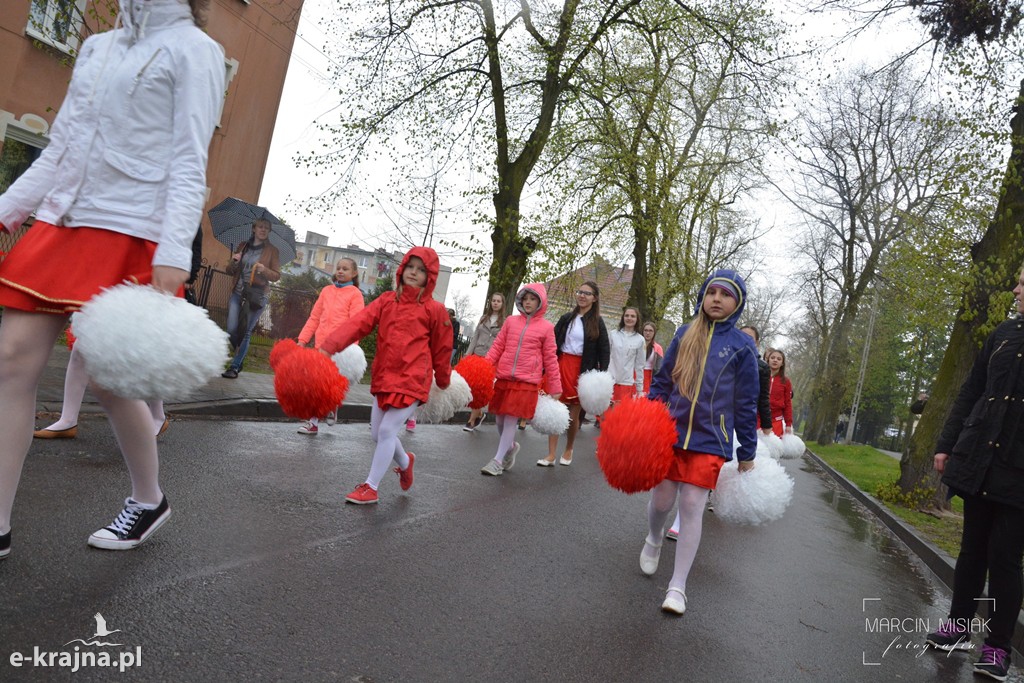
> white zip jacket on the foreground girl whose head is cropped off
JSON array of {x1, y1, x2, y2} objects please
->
[{"x1": 0, "y1": 0, "x2": 225, "y2": 270}]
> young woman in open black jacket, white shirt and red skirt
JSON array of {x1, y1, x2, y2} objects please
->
[{"x1": 537, "y1": 281, "x2": 610, "y2": 467}]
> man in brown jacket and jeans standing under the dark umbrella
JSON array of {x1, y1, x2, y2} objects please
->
[{"x1": 221, "y1": 218, "x2": 281, "y2": 379}]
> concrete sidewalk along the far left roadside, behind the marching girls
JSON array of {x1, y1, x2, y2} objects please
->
[{"x1": 36, "y1": 346, "x2": 382, "y2": 426}]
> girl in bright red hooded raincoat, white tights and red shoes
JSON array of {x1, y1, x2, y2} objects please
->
[{"x1": 321, "y1": 247, "x2": 452, "y2": 505}]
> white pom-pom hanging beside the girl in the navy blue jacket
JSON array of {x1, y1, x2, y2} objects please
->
[{"x1": 715, "y1": 458, "x2": 794, "y2": 524}]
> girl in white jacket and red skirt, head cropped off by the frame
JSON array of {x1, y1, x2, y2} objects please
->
[{"x1": 0, "y1": 0, "x2": 224, "y2": 558}]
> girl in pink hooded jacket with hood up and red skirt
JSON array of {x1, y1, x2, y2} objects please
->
[{"x1": 480, "y1": 284, "x2": 562, "y2": 476}]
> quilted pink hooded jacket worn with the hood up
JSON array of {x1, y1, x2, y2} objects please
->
[{"x1": 485, "y1": 284, "x2": 562, "y2": 393}]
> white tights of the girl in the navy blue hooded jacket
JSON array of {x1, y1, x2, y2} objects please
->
[{"x1": 647, "y1": 479, "x2": 708, "y2": 593}]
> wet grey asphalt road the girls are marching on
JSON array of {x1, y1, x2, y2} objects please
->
[{"x1": 0, "y1": 419, "x2": 1019, "y2": 682}]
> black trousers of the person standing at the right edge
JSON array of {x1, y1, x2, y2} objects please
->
[{"x1": 949, "y1": 496, "x2": 1024, "y2": 650}]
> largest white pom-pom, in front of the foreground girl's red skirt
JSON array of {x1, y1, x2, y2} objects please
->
[{"x1": 72, "y1": 283, "x2": 227, "y2": 401}]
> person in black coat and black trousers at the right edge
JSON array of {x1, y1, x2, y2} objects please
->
[{"x1": 928, "y1": 272, "x2": 1024, "y2": 681}]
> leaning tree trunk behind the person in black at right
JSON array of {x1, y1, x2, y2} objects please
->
[{"x1": 898, "y1": 81, "x2": 1024, "y2": 509}]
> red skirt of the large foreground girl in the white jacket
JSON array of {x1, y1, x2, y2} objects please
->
[{"x1": 0, "y1": 220, "x2": 157, "y2": 313}]
